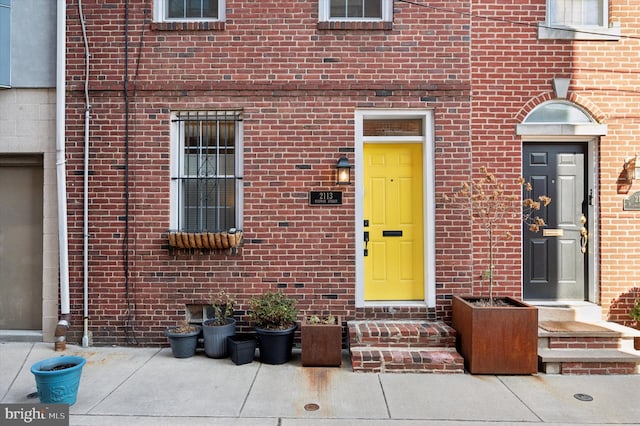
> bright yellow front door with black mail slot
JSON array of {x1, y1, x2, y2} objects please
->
[{"x1": 363, "y1": 143, "x2": 424, "y2": 301}]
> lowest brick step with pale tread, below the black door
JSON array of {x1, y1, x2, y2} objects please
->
[{"x1": 538, "y1": 348, "x2": 640, "y2": 374}]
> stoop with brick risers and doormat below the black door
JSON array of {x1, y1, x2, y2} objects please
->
[{"x1": 538, "y1": 305, "x2": 640, "y2": 375}]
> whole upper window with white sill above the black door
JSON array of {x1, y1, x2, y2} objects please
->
[{"x1": 538, "y1": 0, "x2": 620, "y2": 40}]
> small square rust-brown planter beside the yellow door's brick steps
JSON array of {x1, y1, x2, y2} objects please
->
[{"x1": 300, "y1": 315, "x2": 342, "y2": 367}]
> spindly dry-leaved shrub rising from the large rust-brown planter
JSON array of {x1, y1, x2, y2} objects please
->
[{"x1": 444, "y1": 166, "x2": 551, "y2": 304}]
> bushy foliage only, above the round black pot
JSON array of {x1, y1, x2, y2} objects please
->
[{"x1": 249, "y1": 291, "x2": 298, "y2": 330}]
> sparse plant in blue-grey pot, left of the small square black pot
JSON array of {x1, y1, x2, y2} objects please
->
[{"x1": 202, "y1": 290, "x2": 236, "y2": 358}]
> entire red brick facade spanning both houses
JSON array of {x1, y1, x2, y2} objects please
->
[{"x1": 67, "y1": 0, "x2": 640, "y2": 345}]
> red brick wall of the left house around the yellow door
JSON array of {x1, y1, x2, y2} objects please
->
[{"x1": 67, "y1": 0, "x2": 469, "y2": 344}]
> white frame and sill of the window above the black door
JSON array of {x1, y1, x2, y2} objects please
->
[{"x1": 538, "y1": 0, "x2": 620, "y2": 41}]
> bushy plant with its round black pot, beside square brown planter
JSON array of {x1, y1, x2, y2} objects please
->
[{"x1": 249, "y1": 291, "x2": 298, "y2": 364}]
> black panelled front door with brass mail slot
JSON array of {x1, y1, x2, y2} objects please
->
[{"x1": 522, "y1": 143, "x2": 588, "y2": 301}]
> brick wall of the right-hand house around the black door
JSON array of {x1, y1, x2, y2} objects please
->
[{"x1": 472, "y1": 0, "x2": 640, "y2": 323}]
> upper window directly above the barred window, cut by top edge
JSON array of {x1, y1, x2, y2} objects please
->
[{"x1": 154, "y1": 0, "x2": 225, "y2": 22}]
